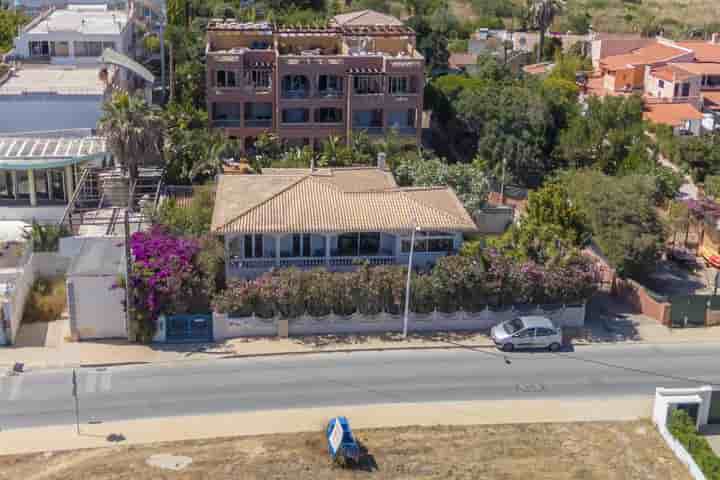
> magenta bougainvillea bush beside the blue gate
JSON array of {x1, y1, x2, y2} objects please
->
[{"x1": 129, "y1": 227, "x2": 202, "y2": 340}]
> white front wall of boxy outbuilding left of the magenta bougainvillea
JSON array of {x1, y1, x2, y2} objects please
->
[{"x1": 67, "y1": 275, "x2": 128, "y2": 340}]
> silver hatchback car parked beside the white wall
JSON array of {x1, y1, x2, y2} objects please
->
[{"x1": 490, "y1": 316, "x2": 562, "y2": 352}]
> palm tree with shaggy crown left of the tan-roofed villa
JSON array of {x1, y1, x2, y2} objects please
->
[{"x1": 98, "y1": 92, "x2": 164, "y2": 210}]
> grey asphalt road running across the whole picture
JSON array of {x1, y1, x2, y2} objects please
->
[{"x1": 0, "y1": 345, "x2": 720, "y2": 429}]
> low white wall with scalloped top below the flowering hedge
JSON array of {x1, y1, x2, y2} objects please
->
[{"x1": 213, "y1": 304, "x2": 585, "y2": 340}]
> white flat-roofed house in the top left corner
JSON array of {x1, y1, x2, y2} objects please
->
[{"x1": 14, "y1": 5, "x2": 133, "y2": 65}]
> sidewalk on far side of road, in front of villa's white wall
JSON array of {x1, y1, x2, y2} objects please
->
[{"x1": 0, "y1": 314, "x2": 720, "y2": 372}]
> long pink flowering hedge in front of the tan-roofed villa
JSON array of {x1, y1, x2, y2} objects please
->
[{"x1": 213, "y1": 251, "x2": 599, "y2": 318}]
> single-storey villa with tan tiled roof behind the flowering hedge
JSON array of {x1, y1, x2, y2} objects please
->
[{"x1": 211, "y1": 167, "x2": 477, "y2": 279}]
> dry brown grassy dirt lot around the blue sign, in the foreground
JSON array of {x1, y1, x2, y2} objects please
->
[{"x1": 0, "y1": 421, "x2": 690, "y2": 480}]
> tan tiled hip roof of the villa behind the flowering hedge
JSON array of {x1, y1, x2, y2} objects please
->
[{"x1": 212, "y1": 169, "x2": 477, "y2": 234}]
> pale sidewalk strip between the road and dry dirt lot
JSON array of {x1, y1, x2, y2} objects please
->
[{"x1": 0, "y1": 396, "x2": 652, "y2": 455}]
